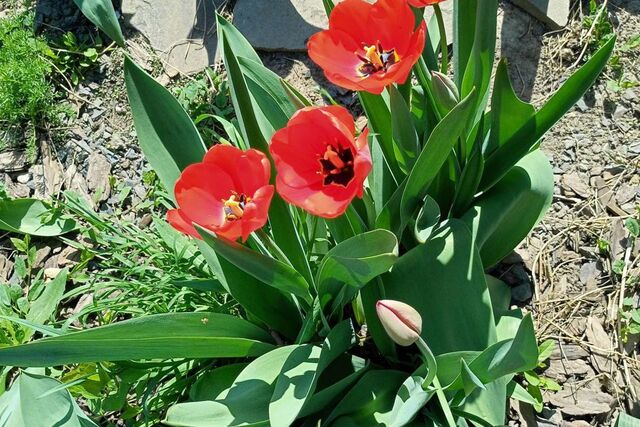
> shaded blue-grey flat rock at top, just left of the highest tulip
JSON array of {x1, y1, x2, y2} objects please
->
[{"x1": 233, "y1": 0, "x2": 328, "y2": 51}]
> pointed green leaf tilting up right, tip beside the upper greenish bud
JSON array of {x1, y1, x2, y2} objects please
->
[{"x1": 400, "y1": 88, "x2": 475, "y2": 231}]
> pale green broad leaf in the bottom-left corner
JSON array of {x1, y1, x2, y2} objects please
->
[{"x1": 0, "y1": 372, "x2": 98, "y2": 427}]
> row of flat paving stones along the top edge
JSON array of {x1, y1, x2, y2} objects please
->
[{"x1": 122, "y1": 0, "x2": 570, "y2": 77}]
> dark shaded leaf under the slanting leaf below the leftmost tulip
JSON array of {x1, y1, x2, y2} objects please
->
[{"x1": 198, "y1": 240, "x2": 300, "y2": 340}]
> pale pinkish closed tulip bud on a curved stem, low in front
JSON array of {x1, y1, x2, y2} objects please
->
[{"x1": 376, "y1": 300, "x2": 422, "y2": 347}]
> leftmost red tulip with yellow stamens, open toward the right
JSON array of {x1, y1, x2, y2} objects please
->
[{"x1": 167, "y1": 145, "x2": 274, "y2": 241}]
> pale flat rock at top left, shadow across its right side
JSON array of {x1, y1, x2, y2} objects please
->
[{"x1": 122, "y1": 0, "x2": 224, "y2": 76}]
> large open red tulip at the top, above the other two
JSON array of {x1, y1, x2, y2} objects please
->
[{"x1": 308, "y1": 0, "x2": 427, "y2": 94}]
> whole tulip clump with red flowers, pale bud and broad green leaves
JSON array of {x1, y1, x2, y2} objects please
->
[{"x1": 0, "y1": 0, "x2": 614, "y2": 427}]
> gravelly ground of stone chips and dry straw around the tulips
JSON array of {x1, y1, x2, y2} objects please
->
[{"x1": 0, "y1": 0, "x2": 640, "y2": 427}]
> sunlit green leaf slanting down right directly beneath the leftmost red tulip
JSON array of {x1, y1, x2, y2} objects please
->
[{"x1": 197, "y1": 227, "x2": 312, "y2": 305}]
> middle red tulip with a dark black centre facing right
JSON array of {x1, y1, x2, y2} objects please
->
[{"x1": 270, "y1": 106, "x2": 371, "y2": 218}]
